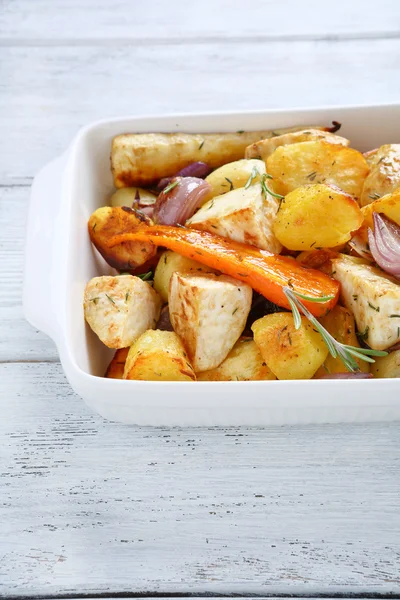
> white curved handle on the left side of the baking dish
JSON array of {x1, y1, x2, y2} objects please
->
[{"x1": 23, "y1": 156, "x2": 66, "y2": 341}]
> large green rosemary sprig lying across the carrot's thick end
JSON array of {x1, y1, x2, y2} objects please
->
[{"x1": 283, "y1": 286, "x2": 387, "y2": 371}]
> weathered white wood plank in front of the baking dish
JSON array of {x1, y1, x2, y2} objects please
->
[{"x1": 0, "y1": 364, "x2": 400, "y2": 596}]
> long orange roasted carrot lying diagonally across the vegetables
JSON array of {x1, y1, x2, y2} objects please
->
[{"x1": 108, "y1": 223, "x2": 339, "y2": 317}]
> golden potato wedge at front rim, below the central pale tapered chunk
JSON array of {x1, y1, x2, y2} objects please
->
[{"x1": 197, "y1": 338, "x2": 276, "y2": 381}]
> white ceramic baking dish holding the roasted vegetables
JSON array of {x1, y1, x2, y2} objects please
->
[{"x1": 24, "y1": 104, "x2": 400, "y2": 426}]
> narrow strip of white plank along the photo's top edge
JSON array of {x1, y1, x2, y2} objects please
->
[{"x1": 0, "y1": 0, "x2": 400, "y2": 43}]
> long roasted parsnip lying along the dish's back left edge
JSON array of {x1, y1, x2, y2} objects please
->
[{"x1": 111, "y1": 127, "x2": 316, "y2": 188}]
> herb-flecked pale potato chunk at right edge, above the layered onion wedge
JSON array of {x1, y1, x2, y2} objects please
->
[{"x1": 360, "y1": 144, "x2": 400, "y2": 206}]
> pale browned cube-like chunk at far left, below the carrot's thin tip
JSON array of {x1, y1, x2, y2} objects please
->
[{"x1": 84, "y1": 275, "x2": 161, "y2": 348}]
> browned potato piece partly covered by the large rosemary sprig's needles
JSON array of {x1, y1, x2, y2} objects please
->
[{"x1": 315, "y1": 304, "x2": 369, "y2": 377}]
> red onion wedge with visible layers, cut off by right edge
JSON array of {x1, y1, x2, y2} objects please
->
[{"x1": 368, "y1": 213, "x2": 400, "y2": 279}]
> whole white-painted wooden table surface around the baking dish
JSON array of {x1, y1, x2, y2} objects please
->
[{"x1": 0, "y1": 0, "x2": 400, "y2": 597}]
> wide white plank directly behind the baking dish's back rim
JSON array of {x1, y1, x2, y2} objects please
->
[{"x1": 0, "y1": 40, "x2": 400, "y2": 183}]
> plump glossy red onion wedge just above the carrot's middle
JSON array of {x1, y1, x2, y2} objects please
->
[{"x1": 154, "y1": 177, "x2": 211, "y2": 225}]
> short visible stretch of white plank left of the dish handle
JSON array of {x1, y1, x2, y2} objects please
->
[{"x1": 0, "y1": 187, "x2": 58, "y2": 360}]
